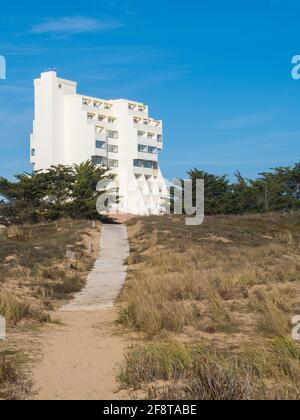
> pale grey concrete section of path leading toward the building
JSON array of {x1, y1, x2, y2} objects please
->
[{"x1": 61, "y1": 224, "x2": 129, "y2": 311}]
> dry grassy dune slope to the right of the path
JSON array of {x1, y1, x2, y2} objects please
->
[{"x1": 119, "y1": 214, "x2": 300, "y2": 399}]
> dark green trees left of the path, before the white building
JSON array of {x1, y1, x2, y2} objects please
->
[{"x1": 0, "y1": 161, "x2": 113, "y2": 225}]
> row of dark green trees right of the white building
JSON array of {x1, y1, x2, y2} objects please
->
[{"x1": 177, "y1": 163, "x2": 300, "y2": 215}]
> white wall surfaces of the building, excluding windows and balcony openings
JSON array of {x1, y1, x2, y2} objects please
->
[{"x1": 31, "y1": 72, "x2": 165, "y2": 214}]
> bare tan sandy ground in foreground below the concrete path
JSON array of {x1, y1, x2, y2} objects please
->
[{"x1": 33, "y1": 309, "x2": 126, "y2": 400}]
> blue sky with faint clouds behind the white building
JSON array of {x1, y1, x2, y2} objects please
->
[{"x1": 0, "y1": 0, "x2": 300, "y2": 179}]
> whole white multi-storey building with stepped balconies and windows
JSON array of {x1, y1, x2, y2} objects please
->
[{"x1": 30, "y1": 71, "x2": 166, "y2": 215}]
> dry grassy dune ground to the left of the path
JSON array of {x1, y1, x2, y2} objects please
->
[{"x1": 0, "y1": 220, "x2": 98, "y2": 399}]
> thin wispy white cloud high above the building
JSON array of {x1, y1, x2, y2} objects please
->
[{"x1": 31, "y1": 16, "x2": 123, "y2": 34}]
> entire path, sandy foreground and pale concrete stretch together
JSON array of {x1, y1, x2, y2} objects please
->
[{"x1": 33, "y1": 225, "x2": 129, "y2": 400}]
